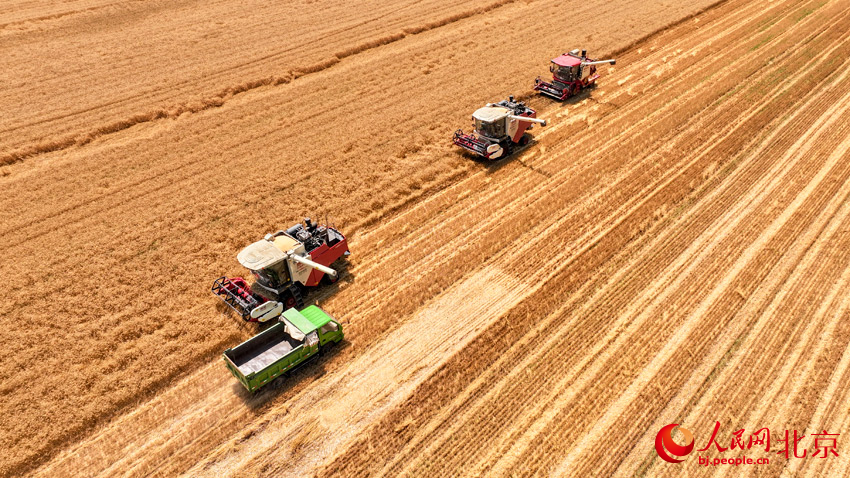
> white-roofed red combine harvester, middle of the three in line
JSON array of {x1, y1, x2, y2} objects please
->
[{"x1": 453, "y1": 96, "x2": 546, "y2": 160}]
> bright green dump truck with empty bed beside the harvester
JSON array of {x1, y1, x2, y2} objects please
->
[{"x1": 224, "y1": 305, "x2": 343, "y2": 392}]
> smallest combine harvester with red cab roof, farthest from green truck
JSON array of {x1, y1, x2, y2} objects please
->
[{"x1": 534, "y1": 50, "x2": 617, "y2": 100}]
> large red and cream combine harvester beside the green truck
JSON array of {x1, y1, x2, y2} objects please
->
[{"x1": 212, "y1": 218, "x2": 349, "y2": 322}]
